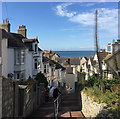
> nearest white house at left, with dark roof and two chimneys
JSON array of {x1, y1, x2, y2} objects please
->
[{"x1": 0, "y1": 20, "x2": 42, "y2": 80}]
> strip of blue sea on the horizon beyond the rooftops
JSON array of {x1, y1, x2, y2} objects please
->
[{"x1": 55, "y1": 51, "x2": 95, "y2": 58}]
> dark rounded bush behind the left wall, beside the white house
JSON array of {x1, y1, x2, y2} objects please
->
[{"x1": 35, "y1": 72, "x2": 48, "y2": 87}]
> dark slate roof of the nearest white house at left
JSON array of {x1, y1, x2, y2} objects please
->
[{"x1": 0, "y1": 29, "x2": 26, "y2": 48}]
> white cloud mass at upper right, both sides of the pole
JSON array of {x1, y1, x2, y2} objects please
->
[{"x1": 56, "y1": 3, "x2": 118, "y2": 35}]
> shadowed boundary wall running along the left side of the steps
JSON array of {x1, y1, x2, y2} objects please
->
[{"x1": 1, "y1": 78, "x2": 45, "y2": 118}]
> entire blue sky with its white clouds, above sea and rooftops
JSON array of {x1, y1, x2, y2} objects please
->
[{"x1": 2, "y1": 2, "x2": 118, "y2": 51}]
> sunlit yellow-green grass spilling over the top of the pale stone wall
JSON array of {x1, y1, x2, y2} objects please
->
[{"x1": 82, "y1": 84, "x2": 120, "y2": 116}]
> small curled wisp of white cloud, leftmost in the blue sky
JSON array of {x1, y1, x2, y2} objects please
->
[{"x1": 56, "y1": 3, "x2": 76, "y2": 17}]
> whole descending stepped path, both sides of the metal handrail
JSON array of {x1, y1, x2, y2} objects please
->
[{"x1": 30, "y1": 93, "x2": 84, "y2": 119}]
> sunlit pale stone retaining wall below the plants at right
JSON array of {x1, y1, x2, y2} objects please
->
[{"x1": 81, "y1": 92, "x2": 114, "y2": 118}]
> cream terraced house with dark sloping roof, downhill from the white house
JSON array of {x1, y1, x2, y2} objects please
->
[{"x1": 42, "y1": 57, "x2": 65, "y2": 86}]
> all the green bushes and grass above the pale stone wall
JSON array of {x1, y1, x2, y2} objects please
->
[{"x1": 79, "y1": 75, "x2": 120, "y2": 116}]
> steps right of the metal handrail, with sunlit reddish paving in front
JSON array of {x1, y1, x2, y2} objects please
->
[{"x1": 59, "y1": 93, "x2": 84, "y2": 119}]
